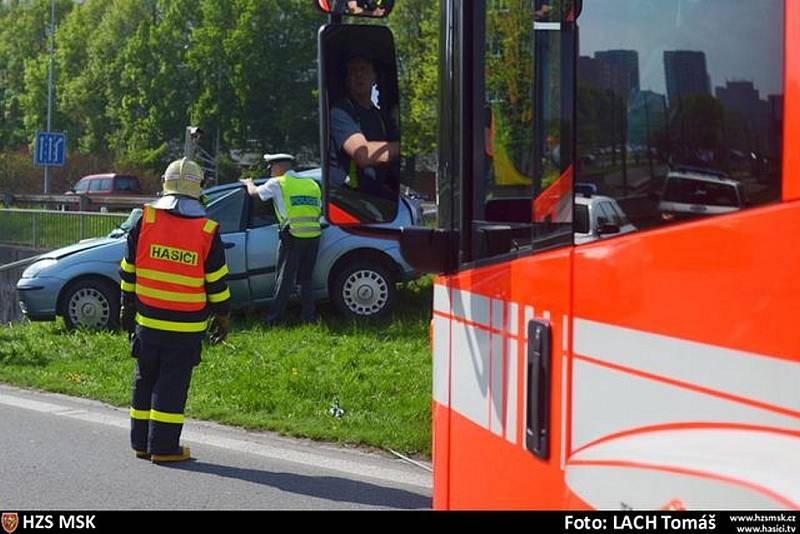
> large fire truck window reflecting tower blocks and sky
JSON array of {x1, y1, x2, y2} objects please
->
[{"x1": 575, "y1": 0, "x2": 784, "y2": 236}]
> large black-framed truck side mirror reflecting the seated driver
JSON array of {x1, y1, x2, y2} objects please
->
[{"x1": 318, "y1": 24, "x2": 400, "y2": 226}]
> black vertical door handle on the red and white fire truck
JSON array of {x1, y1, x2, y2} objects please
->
[{"x1": 525, "y1": 319, "x2": 552, "y2": 460}]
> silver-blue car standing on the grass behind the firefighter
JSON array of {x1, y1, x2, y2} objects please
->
[{"x1": 17, "y1": 169, "x2": 422, "y2": 328}]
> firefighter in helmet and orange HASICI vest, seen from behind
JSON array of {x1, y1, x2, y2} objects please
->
[{"x1": 120, "y1": 158, "x2": 230, "y2": 462}]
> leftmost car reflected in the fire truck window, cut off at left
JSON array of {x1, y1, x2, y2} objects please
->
[{"x1": 575, "y1": 194, "x2": 636, "y2": 245}]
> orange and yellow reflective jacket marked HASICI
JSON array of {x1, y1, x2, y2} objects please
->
[{"x1": 120, "y1": 206, "x2": 230, "y2": 348}]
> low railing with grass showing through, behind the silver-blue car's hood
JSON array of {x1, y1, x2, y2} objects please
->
[{"x1": 0, "y1": 209, "x2": 128, "y2": 248}]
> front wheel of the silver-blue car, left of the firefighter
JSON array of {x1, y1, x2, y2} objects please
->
[{"x1": 62, "y1": 278, "x2": 119, "y2": 330}]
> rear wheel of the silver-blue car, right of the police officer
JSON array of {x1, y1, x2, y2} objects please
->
[{"x1": 331, "y1": 261, "x2": 395, "y2": 318}]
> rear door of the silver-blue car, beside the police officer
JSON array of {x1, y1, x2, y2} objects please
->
[{"x1": 245, "y1": 198, "x2": 278, "y2": 304}]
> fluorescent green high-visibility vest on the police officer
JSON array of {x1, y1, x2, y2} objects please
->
[{"x1": 275, "y1": 174, "x2": 322, "y2": 239}]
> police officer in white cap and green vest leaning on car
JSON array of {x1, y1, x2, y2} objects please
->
[{"x1": 242, "y1": 154, "x2": 322, "y2": 325}]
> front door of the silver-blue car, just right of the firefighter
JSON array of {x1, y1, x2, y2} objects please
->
[{"x1": 206, "y1": 187, "x2": 250, "y2": 307}]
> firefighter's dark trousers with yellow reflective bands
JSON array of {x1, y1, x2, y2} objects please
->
[{"x1": 131, "y1": 339, "x2": 200, "y2": 454}]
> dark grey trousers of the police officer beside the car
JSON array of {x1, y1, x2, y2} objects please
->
[{"x1": 267, "y1": 230, "x2": 319, "y2": 323}]
